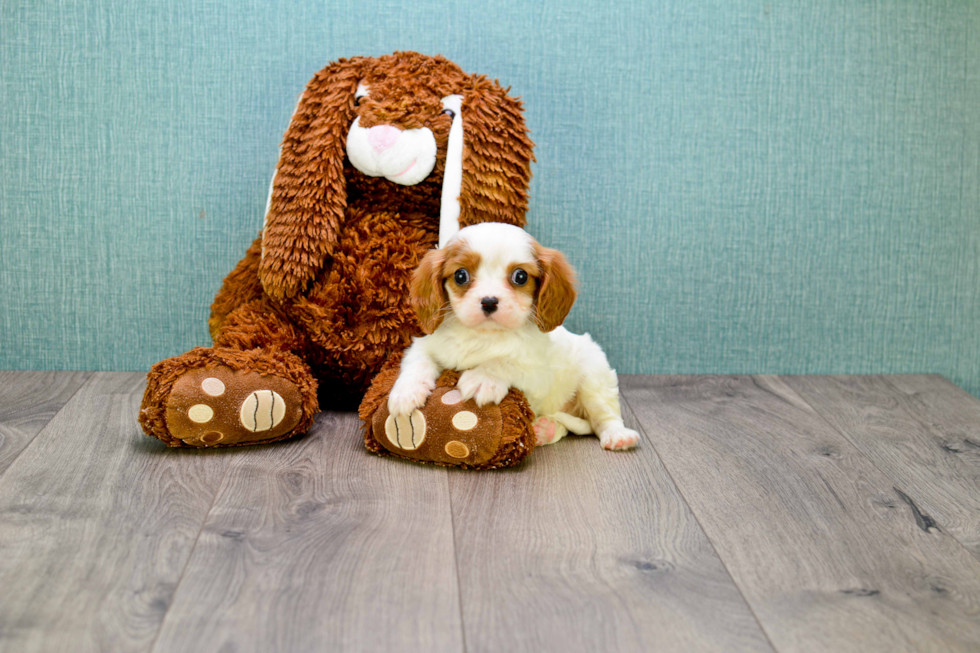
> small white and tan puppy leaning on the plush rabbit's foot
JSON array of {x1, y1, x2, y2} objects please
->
[{"x1": 388, "y1": 223, "x2": 639, "y2": 450}]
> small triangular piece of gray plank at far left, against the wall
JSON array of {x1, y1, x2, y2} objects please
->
[{"x1": 0, "y1": 372, "x2": 91, "y2": 475}]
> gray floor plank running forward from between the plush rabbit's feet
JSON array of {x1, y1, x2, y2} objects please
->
[{"x1": 153, "y1": 413, "x2": 462, "y2": 653}]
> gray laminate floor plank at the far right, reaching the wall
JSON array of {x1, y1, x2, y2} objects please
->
[{"x1": 783, "y1": 375, "x2": 980, "y2": 559}]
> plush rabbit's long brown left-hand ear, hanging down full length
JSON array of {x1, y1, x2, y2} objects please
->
[{"x1": 259, "y1": 58, "x2": 363, "y2": 300}]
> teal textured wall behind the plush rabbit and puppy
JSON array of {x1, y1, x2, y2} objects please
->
[{"x1": 0, "y1": 0, "x2": 980, "y2": 394}]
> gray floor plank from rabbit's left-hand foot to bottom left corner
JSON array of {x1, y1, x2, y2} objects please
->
[{"x1": 0, "y1": 373, "x2": 230, "y2": 653}]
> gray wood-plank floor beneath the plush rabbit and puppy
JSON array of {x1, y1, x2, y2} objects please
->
[{"x1": 0, "y1": 372, "x2": 980, "y2": 653}]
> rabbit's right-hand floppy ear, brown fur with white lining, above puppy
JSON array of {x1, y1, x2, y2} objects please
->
[{"x1": 439, "y1": 76, "x2": 534, "y2": 247}]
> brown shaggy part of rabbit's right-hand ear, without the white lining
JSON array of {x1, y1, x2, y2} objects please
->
[{"x1": 454, "y1": 76, "x2": 534, "y2": 235}]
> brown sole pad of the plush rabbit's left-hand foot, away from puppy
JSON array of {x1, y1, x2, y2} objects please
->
[{"x1": 166, "y1": 367, "x2": 302, "y2": 447}]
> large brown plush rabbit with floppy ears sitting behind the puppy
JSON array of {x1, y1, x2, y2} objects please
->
[{"x1": 139, "y1": 52, "x2": 534, "y2": 468}]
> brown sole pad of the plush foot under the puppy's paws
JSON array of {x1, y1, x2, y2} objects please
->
[{"x1": 371, "y1": 387, "x2": 503, "y2": 466}]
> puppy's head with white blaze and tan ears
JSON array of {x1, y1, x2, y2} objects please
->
[{"x1": 412, "y1": 223, "x2": 576, "y2": 333}]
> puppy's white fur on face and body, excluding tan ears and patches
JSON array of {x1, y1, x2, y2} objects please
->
[{"x1": 388, "y1": 223, "x2": 639, "y2": 450}]
